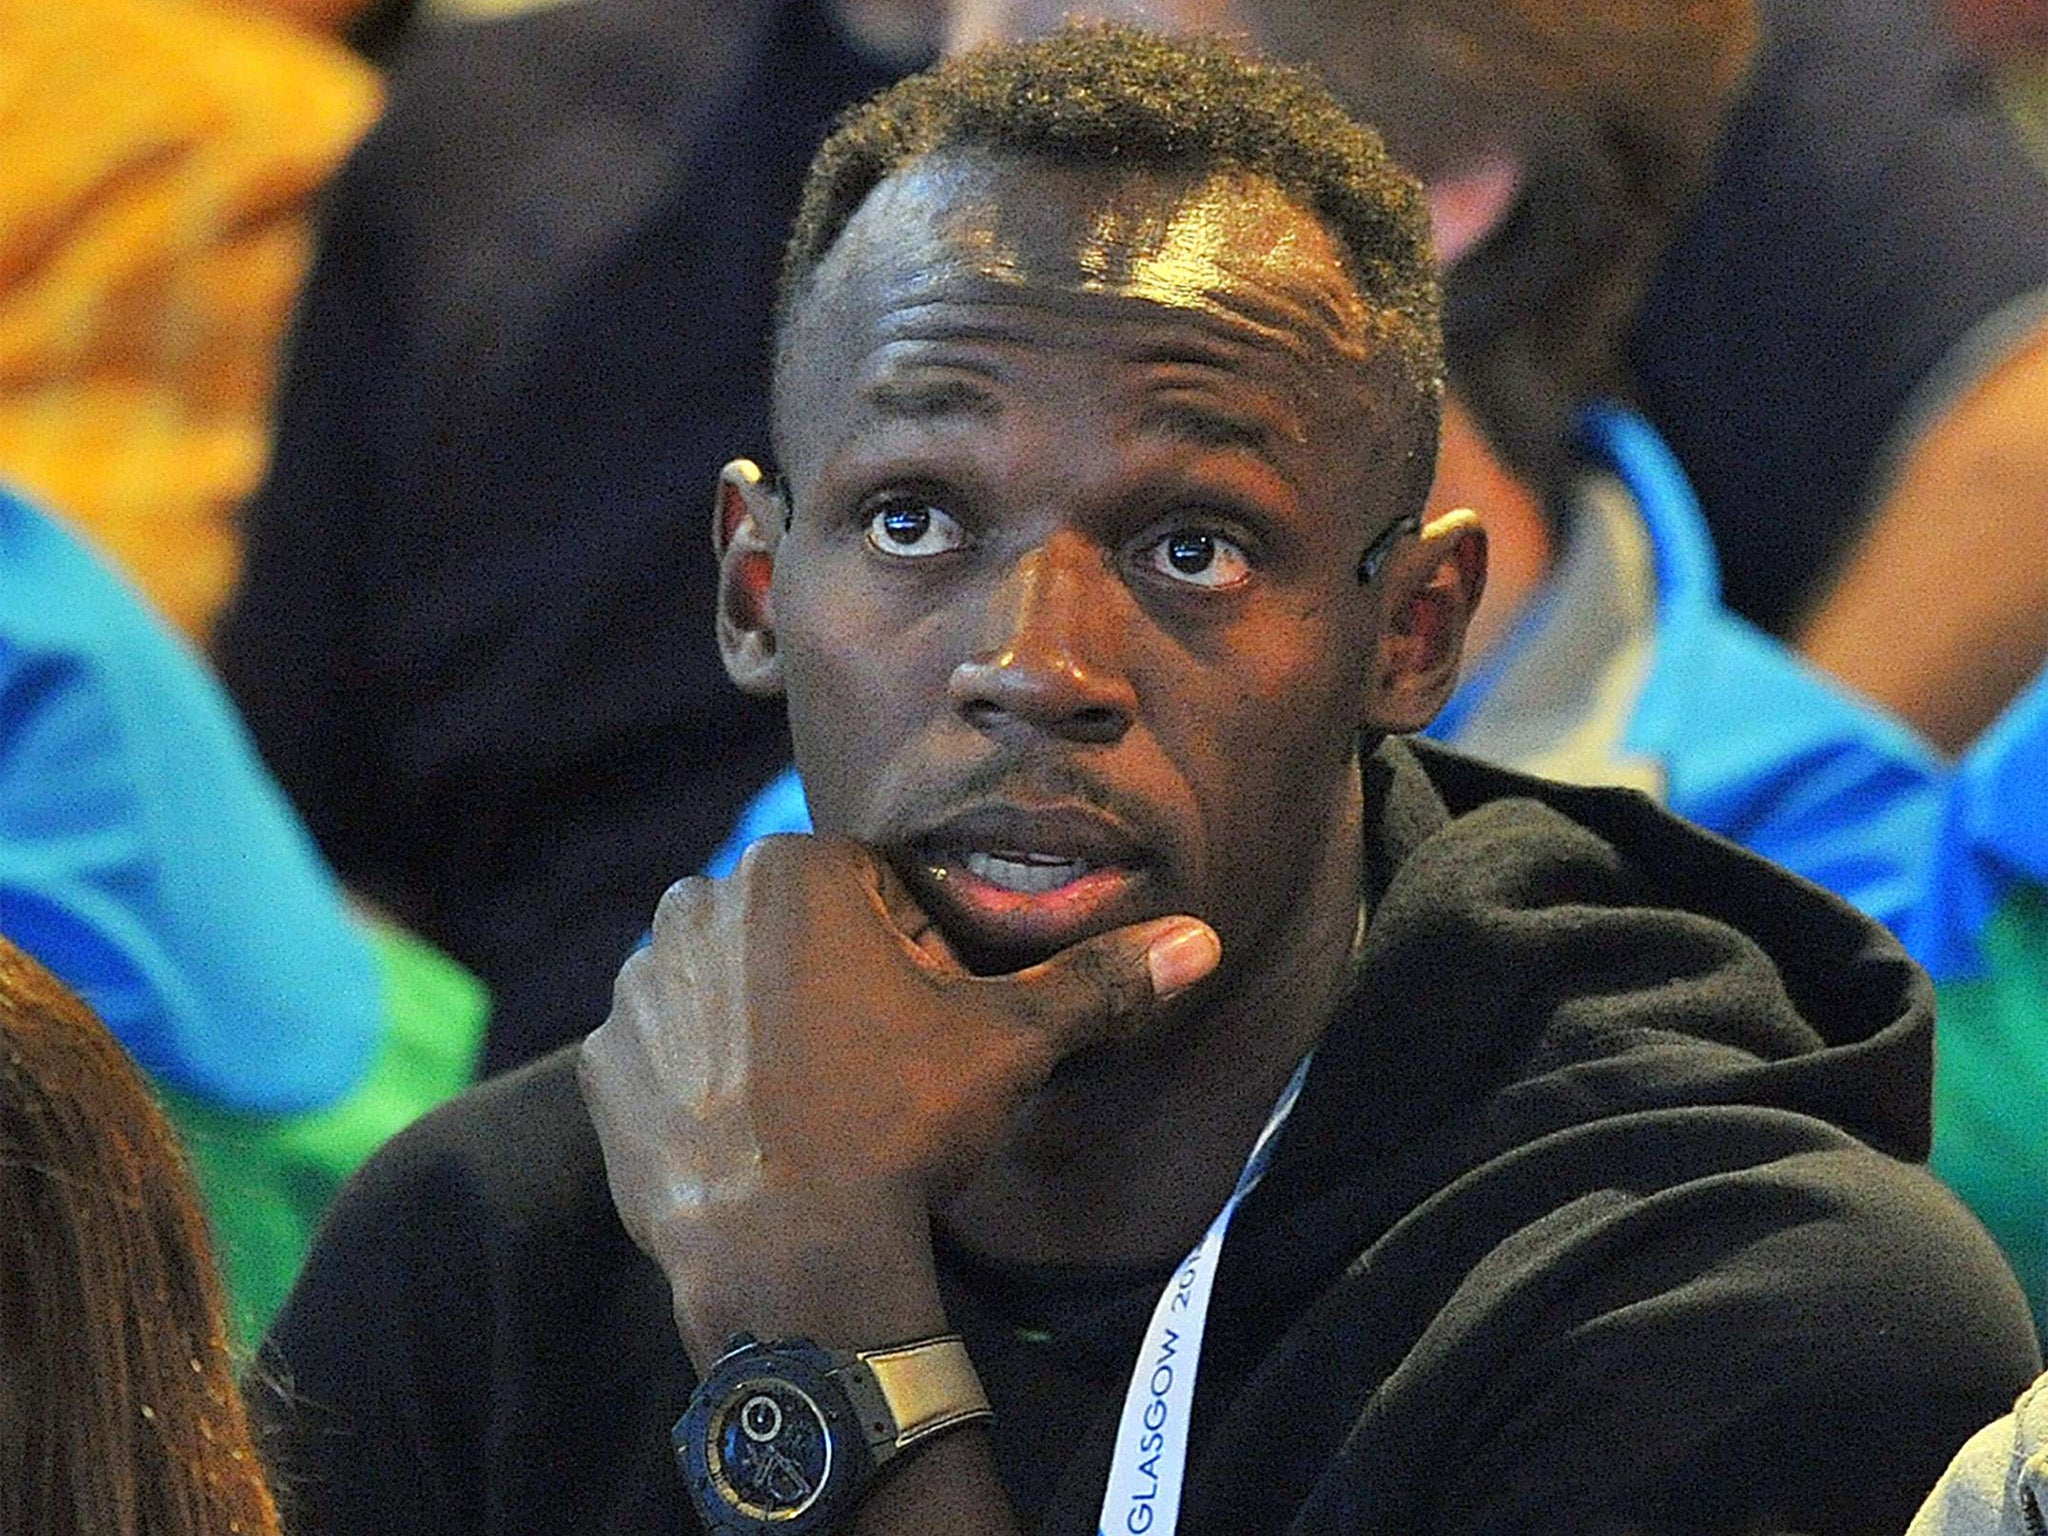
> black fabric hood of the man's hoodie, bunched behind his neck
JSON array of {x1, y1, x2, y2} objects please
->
[{"x1": 1327, "y1": 739, "x2": 1933, "y2": 1161}]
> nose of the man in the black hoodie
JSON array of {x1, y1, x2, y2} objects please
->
[{"x1": 948, "y1": 530, "x2": 1139, "y2": 745}]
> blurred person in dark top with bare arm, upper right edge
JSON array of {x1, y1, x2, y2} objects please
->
[{"x1": 1634, "y1": 0, "x2": 2048, "y2": 750}]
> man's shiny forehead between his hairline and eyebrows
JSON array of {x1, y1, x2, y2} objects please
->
[{"x1": 776, "y1": 154, "x2": 1382, "y2": 454}]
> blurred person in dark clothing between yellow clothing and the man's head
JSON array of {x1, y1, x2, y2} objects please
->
[{"x1": 219, "y1": 0, "x2": 936, "y2": 1069}]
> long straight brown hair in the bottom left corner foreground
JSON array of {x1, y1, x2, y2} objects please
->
[{"x1": 0, "y1": 938, "x2": 276, "y2": 1536}]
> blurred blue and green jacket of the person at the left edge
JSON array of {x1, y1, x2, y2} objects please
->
[{"x1": 0, "y1": 487, "x2": 487, "y2": 1337}]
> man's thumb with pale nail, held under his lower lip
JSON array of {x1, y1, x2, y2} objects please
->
[{"x1": 999, "y1": 918, "x2": 1223, "y2": 1055}]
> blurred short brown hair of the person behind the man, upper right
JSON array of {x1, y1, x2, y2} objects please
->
[{"x1": 1260, "y1": 0, "x2": 1757, "y2": 487}]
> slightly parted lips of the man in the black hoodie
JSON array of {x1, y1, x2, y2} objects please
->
[{"x1": 905, "y1": 803, "x2": 1151, "y2": 971}]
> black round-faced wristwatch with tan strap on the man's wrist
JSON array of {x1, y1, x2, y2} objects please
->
[{"x1": 672, "y1": 1333, "x2": 993, "y2": 1536}]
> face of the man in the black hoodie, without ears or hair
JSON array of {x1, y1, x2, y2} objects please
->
[{"x1": 753, "y1": 158, "x2": 1413, "y2": 987}]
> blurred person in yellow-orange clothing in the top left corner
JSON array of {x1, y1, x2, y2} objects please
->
[{"x1": 0, "y1": 0, "x2": 379, "y2": 637}]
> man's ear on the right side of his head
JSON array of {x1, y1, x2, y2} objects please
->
[{"x1": 1360, "y1": 508, "x2": 1487, "y2": 735}]
